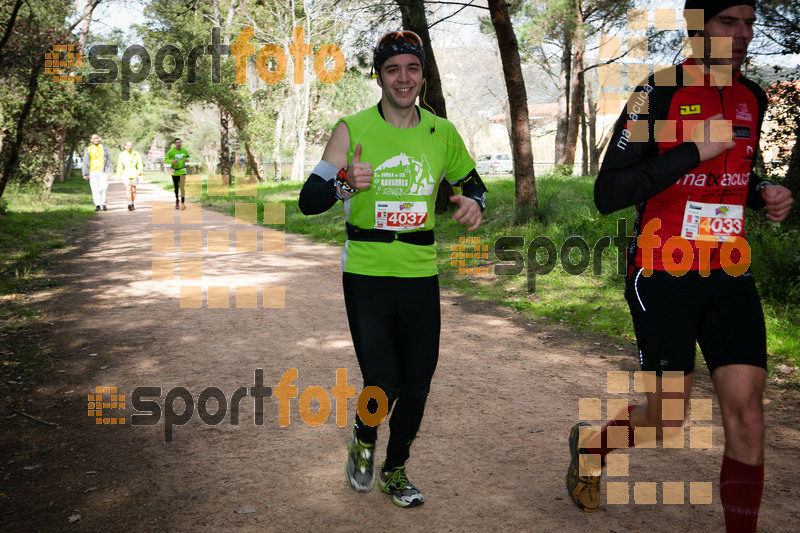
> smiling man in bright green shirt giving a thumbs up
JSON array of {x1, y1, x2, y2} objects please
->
[{"x1": 299, "y1": 31, "x2": 486, "y2": 507}]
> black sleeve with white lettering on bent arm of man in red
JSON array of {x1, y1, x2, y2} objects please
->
[{"x1": 594, "y1": 78, "x2": 700, "y2": 215}]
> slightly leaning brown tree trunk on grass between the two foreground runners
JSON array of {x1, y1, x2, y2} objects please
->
[{"x1": 489, "y1": 0, "x2": 536, "y2": 221}]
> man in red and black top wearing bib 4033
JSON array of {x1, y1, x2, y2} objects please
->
[{"x1": 567, "y1": 0, "x2": 792, "y2": 531}]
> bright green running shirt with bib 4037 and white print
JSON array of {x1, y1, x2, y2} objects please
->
[{"x1": 340, "y1": 106, "x2": 475, "y2": 278}]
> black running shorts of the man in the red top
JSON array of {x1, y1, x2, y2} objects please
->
[{"x1": 625, "y1": 268, "x2": 767, "y2": 375}]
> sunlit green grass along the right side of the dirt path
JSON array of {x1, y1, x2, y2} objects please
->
[{"x1": 148, "y1": 174, "x2": 800, "y2": 386}]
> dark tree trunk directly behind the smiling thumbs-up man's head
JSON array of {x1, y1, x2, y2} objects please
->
[{"x1": 397, "y1": 0, "x2": 456, "y2": 213}]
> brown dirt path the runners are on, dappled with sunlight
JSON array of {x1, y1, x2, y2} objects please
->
[{"x1": 0, "y1": 183, "x2": 800, "y2": 532}]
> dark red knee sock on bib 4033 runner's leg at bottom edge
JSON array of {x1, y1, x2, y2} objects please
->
[{"x1": 719, "y1": 456, "x2": 764, "y2": 533}]
